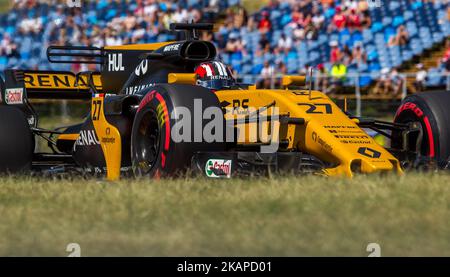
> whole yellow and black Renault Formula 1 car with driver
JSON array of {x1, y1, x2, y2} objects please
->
[{"x1": 0, "y1": 24, "x2": 450, "y2": 180}]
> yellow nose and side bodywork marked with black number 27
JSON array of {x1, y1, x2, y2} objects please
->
[{"x1": 216, "y1": 89, "x2": 402, "y2": 177}]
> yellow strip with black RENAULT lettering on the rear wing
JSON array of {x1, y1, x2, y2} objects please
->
[{"x1": 24, "y1": 72, "x2": 102, "y2": 90}]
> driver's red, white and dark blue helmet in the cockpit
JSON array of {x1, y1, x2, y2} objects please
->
[{"x1": 195, "y1": 61, "x2": 236, "y2": 90}]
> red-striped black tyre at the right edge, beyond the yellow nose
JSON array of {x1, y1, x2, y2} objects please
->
[{"x1": 392, "y1": 91, "x2": 450, "y2": 166}]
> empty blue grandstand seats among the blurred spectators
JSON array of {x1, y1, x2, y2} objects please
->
[{"x1": 0, "y1": 0, "x2": 450, "y2": 84}]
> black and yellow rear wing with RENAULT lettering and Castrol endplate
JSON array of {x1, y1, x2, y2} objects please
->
[{"x1": 2, "y1": 70, "x2": 102, "y2": 99}]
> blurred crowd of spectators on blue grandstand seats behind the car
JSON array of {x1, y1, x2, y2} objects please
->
[{"x1": 0, "y1": 0, "x2": 449, "y2": 94}]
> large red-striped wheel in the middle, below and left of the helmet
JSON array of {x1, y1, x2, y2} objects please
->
[{"x1": 131, "y1": 84, "x2": 225, "y2": 178}]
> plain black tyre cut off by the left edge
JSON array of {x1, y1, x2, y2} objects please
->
[{"x1": 0, "y1": 106, "x2": 34, "y2": 174}]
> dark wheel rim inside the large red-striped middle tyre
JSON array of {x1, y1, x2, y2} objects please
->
[{"x1": 135, "y1": 110, "x2": 160, "y2": 175}]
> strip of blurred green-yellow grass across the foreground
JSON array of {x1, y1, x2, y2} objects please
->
[{"x1": 0, "y1": 173, "x2": 450, "y2": 256}]
